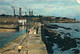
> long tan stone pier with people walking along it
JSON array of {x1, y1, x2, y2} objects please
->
[{"x1": 0, "y1": 22, "x2": 47, "y2": 54}]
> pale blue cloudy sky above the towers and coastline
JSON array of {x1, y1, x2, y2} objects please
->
[{"x1": 0, "y1": 0, "x2": 80, "y2": 20}]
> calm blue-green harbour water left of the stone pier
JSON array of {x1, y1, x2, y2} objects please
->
[{"x1": 0, "y1": 26, "x2": 26, "y2": 48}]
